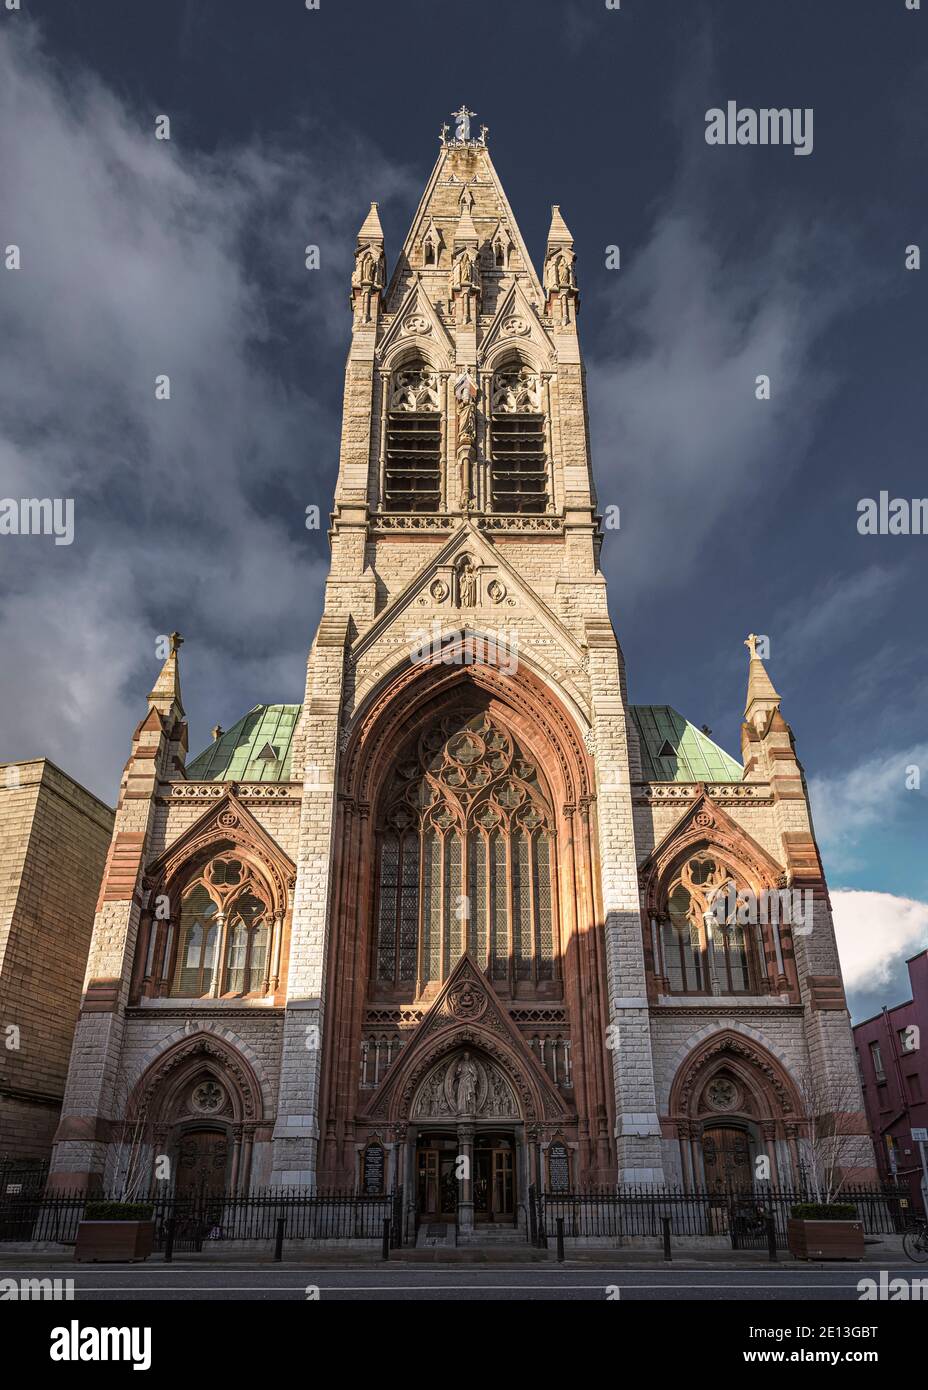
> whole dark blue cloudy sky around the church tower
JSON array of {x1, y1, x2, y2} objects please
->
[{"x1": 0, "y1": 0, "x2": 928, "y2": 1023}]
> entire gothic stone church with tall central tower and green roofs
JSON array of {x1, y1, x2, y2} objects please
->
[{"x1": 51, "y1": 108, "x2": 874, "y2": 1229}]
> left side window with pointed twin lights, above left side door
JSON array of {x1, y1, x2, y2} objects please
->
[{"x1": 169, "y1": 855, "x2": 272, "y2": 998}]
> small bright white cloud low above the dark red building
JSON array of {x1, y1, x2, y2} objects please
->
[{"x1": 831, "y1": 888, "x2": 928, "y2": 1004}]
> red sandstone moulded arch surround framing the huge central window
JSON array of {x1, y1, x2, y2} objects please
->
[{"x1": 320, "y1": 660, "x2": 615, "y2": 1184}]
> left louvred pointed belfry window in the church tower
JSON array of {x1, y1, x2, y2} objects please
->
[{"x1": 383, "y1": 361, "x2": 442, "y2": 512}]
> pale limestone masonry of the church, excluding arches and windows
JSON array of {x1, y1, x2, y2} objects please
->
[{"x1": 48, "y1": 119, "x2": 872, "y2": 1186}]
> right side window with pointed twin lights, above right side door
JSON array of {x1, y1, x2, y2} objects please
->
[{"x1": 661, "y1": 852, "x2": 759, "y2": 994}]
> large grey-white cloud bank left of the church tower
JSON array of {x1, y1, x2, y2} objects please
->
[{"x1": 0, "y1": 22, "x2": 411, "y2": 798}]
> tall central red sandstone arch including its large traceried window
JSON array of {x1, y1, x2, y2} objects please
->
[{"x1": 320, "y1": 647, "x2": 615, "y2": 1184}]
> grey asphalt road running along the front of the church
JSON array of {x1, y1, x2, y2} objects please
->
[{"x1": 0, "y1": 1261, "x2": 928, "y2": 1302}]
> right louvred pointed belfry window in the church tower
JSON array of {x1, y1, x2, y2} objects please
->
[{"x1": 490, "y1": 361, "x2": 547, "y2": 513}]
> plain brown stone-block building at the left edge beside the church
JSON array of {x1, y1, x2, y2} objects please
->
[{"x1": 0, "y1": 758, "x2": 113, "y2": 1159}]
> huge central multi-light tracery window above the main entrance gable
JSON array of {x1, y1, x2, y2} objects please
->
[{"x1": 372, "y1": 713, "x2": 557, "y2": 994}]
